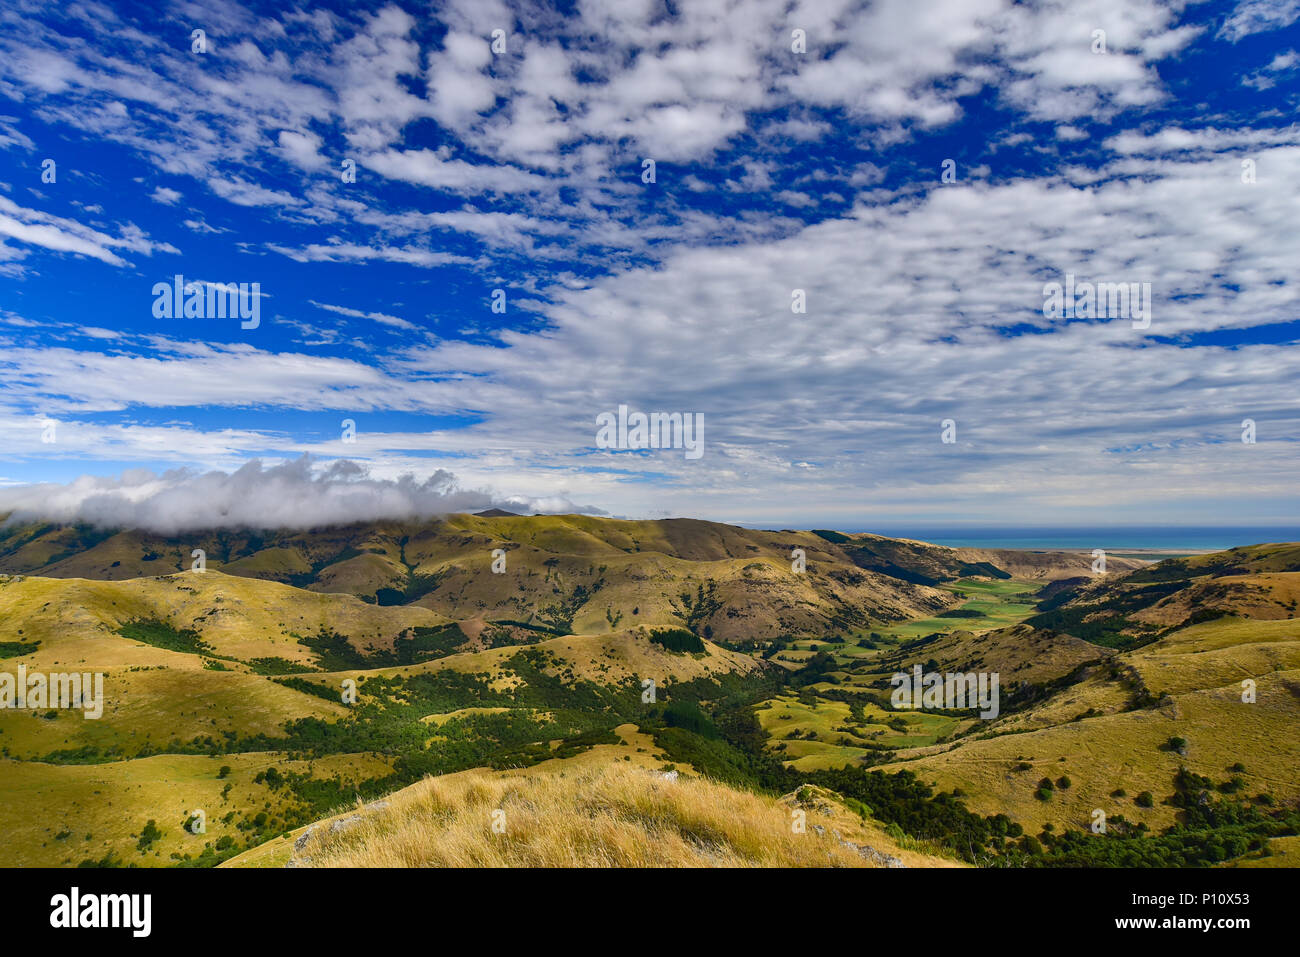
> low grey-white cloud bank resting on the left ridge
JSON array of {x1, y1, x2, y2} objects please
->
[{"x1": 0, "y1": 455, "x2": 605, "y2": 534}]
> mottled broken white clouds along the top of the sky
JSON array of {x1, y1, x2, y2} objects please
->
[{"x1": 0, "y1": 0, "x2": 1211, "y2": 261}]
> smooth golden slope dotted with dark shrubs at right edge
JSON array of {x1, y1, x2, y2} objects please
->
[{"x1": 863, "y1": 572, "x2": 1300, "y2": 852}]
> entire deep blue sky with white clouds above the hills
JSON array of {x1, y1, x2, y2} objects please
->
[{"x1": 0, "y1": 0, "x2": 1300, "y2": 528}]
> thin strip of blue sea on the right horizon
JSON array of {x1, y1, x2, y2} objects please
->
[{"x1": 840, "y1": 525, "x2": 1300, "y2": 553}]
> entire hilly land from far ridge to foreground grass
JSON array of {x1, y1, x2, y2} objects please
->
[{"x1": 0, "y1": 515, "x2": 1300, "y2": 866}]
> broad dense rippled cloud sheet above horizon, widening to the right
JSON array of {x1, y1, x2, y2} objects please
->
[{"x1": 0, "y1": 130, "x2": 1300, "y2": 521}]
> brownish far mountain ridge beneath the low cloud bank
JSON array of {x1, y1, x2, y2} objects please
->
[{"x1": 0, "y1": 510, "x2": 1141, "y2": 641}]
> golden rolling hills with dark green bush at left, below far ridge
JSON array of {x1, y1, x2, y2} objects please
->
[{"x1": 0, "y1": 561, "x2": 779, "y2": 866}]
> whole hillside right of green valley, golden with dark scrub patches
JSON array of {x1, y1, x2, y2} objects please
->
[{"x1": 728, "y1": 546, "x2": 1300, "y2": 859}]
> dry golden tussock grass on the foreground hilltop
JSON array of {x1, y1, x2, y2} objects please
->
[{"x1": 294, "y1": 766, "x2": 889, "y2": 867}]
